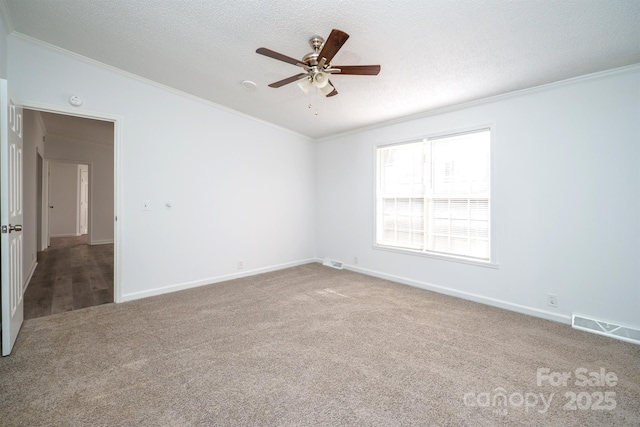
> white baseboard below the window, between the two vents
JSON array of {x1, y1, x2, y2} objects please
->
[{"x1": 338, "y1": 260, "x2": 571, "y2": 325}]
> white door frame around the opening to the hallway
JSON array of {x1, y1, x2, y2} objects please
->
[{"x1": 16, "y1": 99, "x2": 124, "y2": 303}]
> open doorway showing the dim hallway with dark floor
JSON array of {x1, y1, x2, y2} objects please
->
[{"x1": 24, "y1": 107, "x2": 116, "y2": 319}]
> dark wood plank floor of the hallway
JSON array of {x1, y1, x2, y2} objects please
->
[{"x1": 24, "y1": 235, "x2": 113, "y2": 320}]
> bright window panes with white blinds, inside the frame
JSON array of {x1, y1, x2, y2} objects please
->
[{"x1": 376, "y1": 129, "x2": 491, "y2": 261}]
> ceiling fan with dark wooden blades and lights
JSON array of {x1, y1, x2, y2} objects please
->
[{"x1": 256, "y1": 29, "x2": 380, "y2": 96}]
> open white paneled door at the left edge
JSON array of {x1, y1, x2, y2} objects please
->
[{"x1": 0, "y1": 80, "x2": 24, "y2": 356}]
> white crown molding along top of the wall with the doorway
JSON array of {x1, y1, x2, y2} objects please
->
[{"x1": 11, "y1": 30, "x2": 315, "y2": 142}]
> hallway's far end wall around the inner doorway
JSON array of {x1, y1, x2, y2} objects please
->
[{"x1": 45, "y1": 135, "x2": 115, "y2": 244}]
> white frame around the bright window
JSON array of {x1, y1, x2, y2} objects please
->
[{"x1": 372, "y1": 124, "x2": 498, "y2": 268}]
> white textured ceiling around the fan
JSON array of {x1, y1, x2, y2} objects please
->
[{"x1": 2, "y1": 0, "x2": 640, "y2": 138}]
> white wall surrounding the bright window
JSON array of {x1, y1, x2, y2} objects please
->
[{"x1": 317, "y1": 67, "x2": 640, "y2": 327}]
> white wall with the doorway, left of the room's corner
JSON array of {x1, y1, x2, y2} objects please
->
[{"x1": 8, "y1": 35, "x2": 315, "y2": 300}]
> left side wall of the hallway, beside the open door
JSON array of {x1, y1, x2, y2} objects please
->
[{"x1": 21, "y1": 109, "x2": 45, "y2": 281}]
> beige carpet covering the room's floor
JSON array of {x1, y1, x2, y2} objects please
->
[{"x1": 0, "y1": 264, "x2": 640, "y2": 426}]
